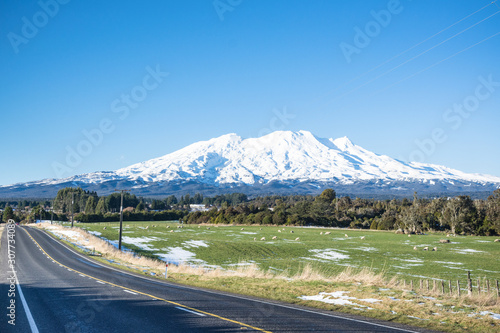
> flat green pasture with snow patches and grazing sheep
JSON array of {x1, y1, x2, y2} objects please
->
[{"x1": 76, "y1": 222, "x2": 500, "y2": 282}]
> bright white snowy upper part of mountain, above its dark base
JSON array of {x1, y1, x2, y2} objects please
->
[{"x1": 109, "y1": 131, "x2": 500, "y2": 185}]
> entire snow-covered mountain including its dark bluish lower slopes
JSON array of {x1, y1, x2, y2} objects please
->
[{"x1": 0, "y1": 131, "x2": 500, "y2": 197}]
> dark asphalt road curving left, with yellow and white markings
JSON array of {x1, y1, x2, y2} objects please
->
[{"x1": 0, "y1": 226, "x2": 440, "y2": 333}]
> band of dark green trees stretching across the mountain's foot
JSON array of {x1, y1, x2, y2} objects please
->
[{"x1": 2, "y1": 187, "x2": 500, "y2": 235}]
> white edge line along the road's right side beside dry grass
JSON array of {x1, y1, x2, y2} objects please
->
[{"x1": 27, "y1": 229, "x2": 419, "y2": 333}]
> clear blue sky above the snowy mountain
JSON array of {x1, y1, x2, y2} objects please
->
[{"x1": 0, "y1": 0, "x2": 500, "y2": 185}]
